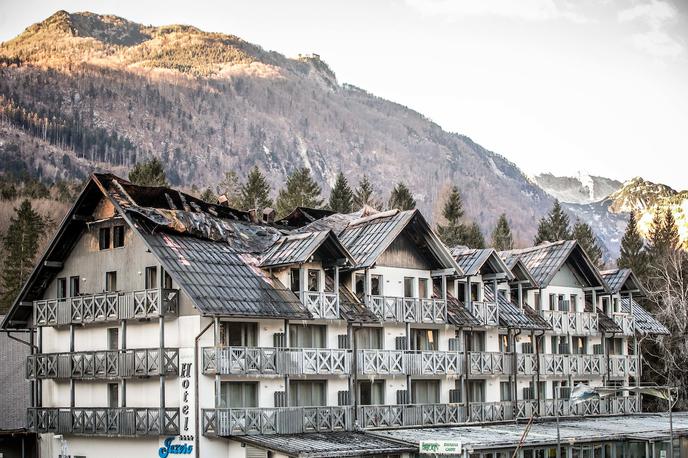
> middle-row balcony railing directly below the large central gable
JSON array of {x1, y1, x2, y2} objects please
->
[{"x1": 357, "y1": 349, "x2": 463, "y2": 375}]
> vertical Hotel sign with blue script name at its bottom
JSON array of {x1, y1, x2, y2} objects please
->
[{"x1": 158, "y1": 348, "x2": 196, "y2": 458}]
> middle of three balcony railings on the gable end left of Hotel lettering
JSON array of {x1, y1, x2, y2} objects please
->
[{"x1": 26, "y1": 348, "x2": 179, "y2": 379}]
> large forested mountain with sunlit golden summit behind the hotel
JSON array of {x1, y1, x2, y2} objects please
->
[{"x1": 0, "y1": 11, "x2": 552, "y2": 243}]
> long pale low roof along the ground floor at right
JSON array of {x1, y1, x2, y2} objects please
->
[{"x1": 369, "y1": 412, "x2": 688, "y2": 452}]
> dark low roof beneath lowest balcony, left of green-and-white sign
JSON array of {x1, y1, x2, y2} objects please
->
[{"x1": 235, "y1": 431, "x2": 418, "y2": 458}]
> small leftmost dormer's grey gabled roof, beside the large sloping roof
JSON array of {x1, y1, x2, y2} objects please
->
[{"x1": 260, "y1": 230, "x2": 355, "y2": 267}]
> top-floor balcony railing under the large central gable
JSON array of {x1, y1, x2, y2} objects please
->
[{"x1": 366, "y1": 295, "x2": 447, "y2": 323}]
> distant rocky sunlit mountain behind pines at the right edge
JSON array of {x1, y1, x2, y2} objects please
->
[{"x1": 562, "y1": 177, "x2": 688, "y2": 261}]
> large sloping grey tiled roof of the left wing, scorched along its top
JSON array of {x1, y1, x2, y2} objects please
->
[{"x1": 144, "y1": 234, "x2": 312, "y2": 319}]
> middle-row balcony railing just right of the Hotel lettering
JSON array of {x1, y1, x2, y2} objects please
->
[{"x1": 203, "y1": 347, "x2": 351, "y2": 375}]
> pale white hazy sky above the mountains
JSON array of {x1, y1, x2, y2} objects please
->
[{"x1": 0, "y1": 0, "x2": 688, "y2": 189}]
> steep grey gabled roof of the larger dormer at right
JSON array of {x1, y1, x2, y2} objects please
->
[{"x1": 504, "y1": 240, "x2": 607, "y2": 291}]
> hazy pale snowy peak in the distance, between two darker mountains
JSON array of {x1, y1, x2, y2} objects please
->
[{"x1": 533, "y1": 172, "x2": 623, "y2": 204}]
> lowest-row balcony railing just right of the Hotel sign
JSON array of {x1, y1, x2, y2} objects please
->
[{"x1": 203, "y1": 406, "x2": 352, "y2": 436}]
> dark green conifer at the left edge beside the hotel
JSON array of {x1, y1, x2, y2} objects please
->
[{"x1": 0, "y1": 199, "x2": 51, "y2": 314}]
